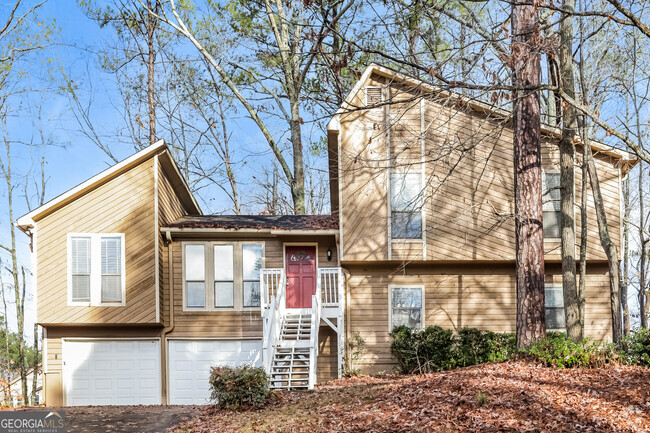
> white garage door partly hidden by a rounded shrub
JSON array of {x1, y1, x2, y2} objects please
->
[{"x1": 169, "y1": 340, "x2": 262, "y2": 404}]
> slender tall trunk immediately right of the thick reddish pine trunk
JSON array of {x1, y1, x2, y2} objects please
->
[{"x1": 558, "y1": 0, "x2": 582, "y2": 343}]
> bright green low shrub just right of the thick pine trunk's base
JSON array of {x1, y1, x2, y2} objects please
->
[{"x1": 522, "y1": 332, "x2": 619, "y2": 368}]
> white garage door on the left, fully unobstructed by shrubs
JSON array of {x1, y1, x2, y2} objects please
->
[{"x1": 63, "y1": 340, "x2": 161, "y2": 406}]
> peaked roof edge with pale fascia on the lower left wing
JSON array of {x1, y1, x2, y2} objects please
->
[{"x1": 16, "y1": 140, "x2": 201, "y2": 231}]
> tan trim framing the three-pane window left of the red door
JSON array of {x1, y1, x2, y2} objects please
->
[{"x1": 181, "y1": 241, "x2": 266, "y2": 313}]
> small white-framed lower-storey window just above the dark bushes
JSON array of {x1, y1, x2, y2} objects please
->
[{"x1": 389, "y1": 286, "x2": 424, "y2": 331}]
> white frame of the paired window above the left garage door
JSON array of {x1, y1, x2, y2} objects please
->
[{"x1": 67, "y1": 233, "x2": 126, "y2": 307}]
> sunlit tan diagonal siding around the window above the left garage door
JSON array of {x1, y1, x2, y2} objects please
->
[{"x1": 37, "y1": 160, "x2": 156, "y2": 324}]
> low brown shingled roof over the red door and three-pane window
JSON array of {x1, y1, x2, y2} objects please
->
[{"x1": 161, "y1": 215, "x2": 339, "y2": 232}]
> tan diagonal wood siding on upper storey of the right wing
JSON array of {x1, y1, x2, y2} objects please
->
[{"x1": 339, "y1": 71, "x2": 620, "y2": 262}]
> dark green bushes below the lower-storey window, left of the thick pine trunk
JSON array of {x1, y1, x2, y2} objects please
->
[{"x1": 391, "y1": 326, "x2": 516, "y2": 373}]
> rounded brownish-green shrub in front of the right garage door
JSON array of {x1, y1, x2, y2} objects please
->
[{"x1": 210, "y1": 366, "x2": 270, "y2": 409}]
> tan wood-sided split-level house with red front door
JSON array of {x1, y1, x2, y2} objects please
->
[{"x1": 18, "y1": 65, "x2": 636, "y2": 405}]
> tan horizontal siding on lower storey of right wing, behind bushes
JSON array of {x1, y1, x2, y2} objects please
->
[{"x1": 347, "y1": 265, "x2": 611, "y2": 373}]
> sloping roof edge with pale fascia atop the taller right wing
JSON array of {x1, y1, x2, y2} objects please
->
[{"x1": 327, "y1": 63, "x2": 639, "y2": 173}]
